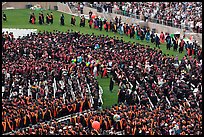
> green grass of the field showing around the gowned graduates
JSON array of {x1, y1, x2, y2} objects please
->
[{"x1": 2, "y1": 9, "x2": 184, "y2": 107}]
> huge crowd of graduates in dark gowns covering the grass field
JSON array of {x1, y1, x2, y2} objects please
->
[{"x1": 2, "y1": 4, "x2": 202, "y2": 135}]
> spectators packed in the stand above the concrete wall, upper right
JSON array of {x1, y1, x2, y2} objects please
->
[{"x1": 86, "y1": 2, "x2": 202, "y2": 33}]
